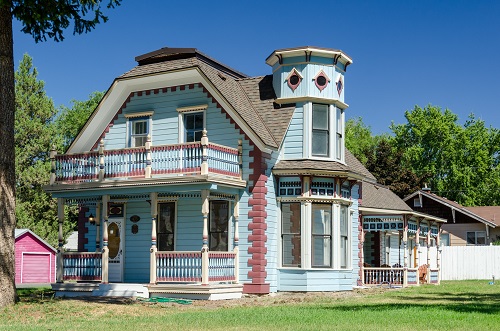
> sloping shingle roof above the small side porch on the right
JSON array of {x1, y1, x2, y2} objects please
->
[{"x1": 361, "y1": 182, "x2": 412, "y2": 211}]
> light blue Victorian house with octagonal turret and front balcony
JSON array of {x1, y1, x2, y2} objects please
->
[{"x1": 46, "y1": 46, "x2": 441, "y2": 299}]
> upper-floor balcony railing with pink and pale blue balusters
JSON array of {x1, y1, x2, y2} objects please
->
[{"x1": 50, "y1": 131, "x2": 242, "y2": 184}]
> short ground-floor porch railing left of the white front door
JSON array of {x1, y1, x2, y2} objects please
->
[{"x1": 63, "y1": 252, "x2": 102, "y2": 281}]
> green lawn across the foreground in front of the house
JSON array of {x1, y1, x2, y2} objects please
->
[{"x1": 0, "y1": 280, "x2": 500, "y2": 331}]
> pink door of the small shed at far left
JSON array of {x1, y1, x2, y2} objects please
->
[{"x1": 21, "y1": 253, "x2": 51, "y2": 283}]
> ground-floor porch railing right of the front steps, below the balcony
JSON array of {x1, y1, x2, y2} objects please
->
[{"x1": 156, "y1": 251, "x2": 236, "y2": 283}]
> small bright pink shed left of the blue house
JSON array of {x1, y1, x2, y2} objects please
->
[{"x1": 15, "y1": 229, "x2": 56, "y2": 284}]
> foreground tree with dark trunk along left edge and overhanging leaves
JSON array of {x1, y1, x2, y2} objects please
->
[{"x1": 0, "y1": 0, "x2": 121, "y2": 307}]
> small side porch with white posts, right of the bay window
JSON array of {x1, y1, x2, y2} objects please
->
[{"x1": 360, "y1": 213, "x2": 444, "y2": 287}]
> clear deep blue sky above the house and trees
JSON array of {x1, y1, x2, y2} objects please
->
[{"x1": 14, "y1": 0, "x2": 500, "y2": 134}]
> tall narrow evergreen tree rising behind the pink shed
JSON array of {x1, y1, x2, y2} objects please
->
[{"x1": 14, "y1": 54, "x2": 75, "y2": 247}]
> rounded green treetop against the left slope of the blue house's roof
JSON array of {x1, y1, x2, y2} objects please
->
[{"x1": 56, "y1": 92, "x2": 104, "y2": 151}]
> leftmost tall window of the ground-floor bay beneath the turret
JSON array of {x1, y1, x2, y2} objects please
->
[{"x1": 281, "y1": 202, "x2": 302, "y2": 267}]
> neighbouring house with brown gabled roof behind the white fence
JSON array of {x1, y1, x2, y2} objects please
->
[{"x1": 404, "y1": 188, "x2": 500, "y2": 246}]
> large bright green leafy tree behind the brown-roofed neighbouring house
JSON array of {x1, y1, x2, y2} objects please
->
[{"x1": 391, "y1": 105, "x2": 500, "y2": 206}]
